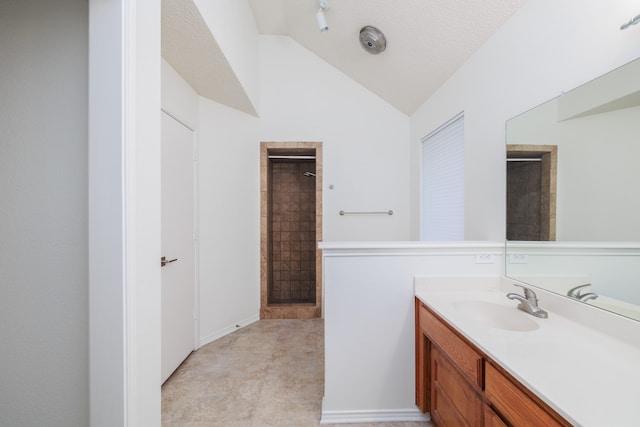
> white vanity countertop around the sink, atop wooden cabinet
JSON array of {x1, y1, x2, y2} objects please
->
[{"x1": 415, "y1": 277, "x2": 640, "y2": 427}]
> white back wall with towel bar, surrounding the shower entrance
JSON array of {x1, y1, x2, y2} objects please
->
[{"x1": 255, "y1": 36, "x2": 409, "y2": 241}]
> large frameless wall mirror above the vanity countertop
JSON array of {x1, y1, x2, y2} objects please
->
[{"x1": 505, "y1": 59, "x2": 640, "y2": 320}]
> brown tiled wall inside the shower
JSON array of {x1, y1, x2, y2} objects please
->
[{"x1": 269, "y1": 162, "x2": 316, "y2": 304}]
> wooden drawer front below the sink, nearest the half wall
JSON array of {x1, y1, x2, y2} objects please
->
[{"x1": 420, "y1": 303, "x2": 482, "y2": 387}]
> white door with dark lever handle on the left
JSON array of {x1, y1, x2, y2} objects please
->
[{"x1": 161, "y1": 112, "x2": 196, "y2": 382}]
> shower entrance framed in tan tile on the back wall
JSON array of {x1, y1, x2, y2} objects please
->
[{"x1": 260, "y1": 142, "x2": 322, "y2": 319}]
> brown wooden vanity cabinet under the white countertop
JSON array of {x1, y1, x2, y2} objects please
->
[{"x1": 415, "y1": 298, "x2": 571, "y2": 427}]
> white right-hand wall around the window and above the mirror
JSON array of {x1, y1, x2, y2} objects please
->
[{"x1": 410, "y1": 0, "x2": 640, "y2": 240}]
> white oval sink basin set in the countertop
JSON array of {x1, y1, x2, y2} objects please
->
[{"x1": 453, "y1": 301, "x2": 539, "y2": 331}]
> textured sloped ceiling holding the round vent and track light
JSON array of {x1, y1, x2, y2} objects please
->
[{"x1": 249, "y1": 0, "x2": 526, "y2": 114}]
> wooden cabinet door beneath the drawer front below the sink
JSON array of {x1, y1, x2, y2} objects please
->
[{"x1": 431, "y1": 346, "x2": 482, "y2": 427}]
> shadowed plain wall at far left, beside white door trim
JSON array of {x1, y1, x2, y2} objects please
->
[{"x1": 0, "y1": 0, "x2": 89, "y2": 427}]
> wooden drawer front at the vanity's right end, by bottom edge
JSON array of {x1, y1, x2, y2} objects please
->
[{"x1": 484, "y1": 363, "x2": 564, "y2": 427}]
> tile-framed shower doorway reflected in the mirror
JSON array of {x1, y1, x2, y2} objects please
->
[{"x1": 507, "y1": 144, "x2": 558, "y2": 241}]
